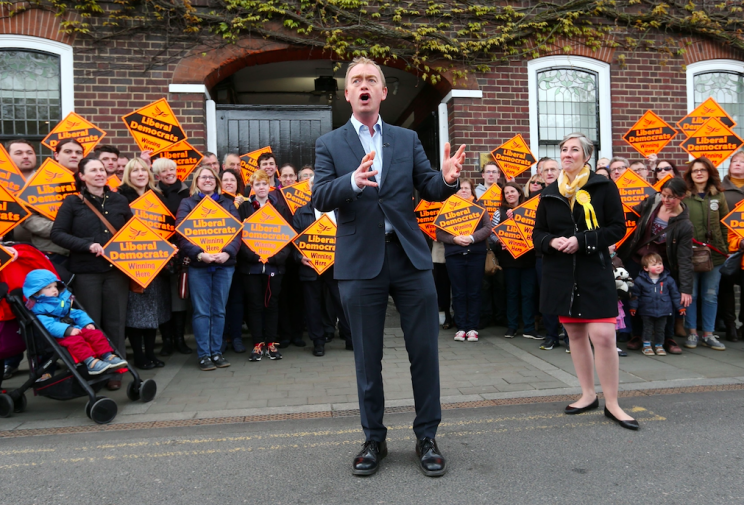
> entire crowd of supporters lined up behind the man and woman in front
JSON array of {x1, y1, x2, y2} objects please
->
[{"x1": 4, "y1": 133, "x2": 744, "y2": 389}]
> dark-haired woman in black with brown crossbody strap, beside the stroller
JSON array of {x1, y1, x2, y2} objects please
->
[{"x1": 51, "y1": 158, "x2": 132, "y2": 391}]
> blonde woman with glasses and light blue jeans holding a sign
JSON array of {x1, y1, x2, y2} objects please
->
[{"x1": 176, "y1": 165, "x2": 241, "y2": 371}]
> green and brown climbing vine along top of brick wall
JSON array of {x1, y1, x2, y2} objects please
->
[{"x1": 5, "y1": 0, "x2": 744, "y2": 82}]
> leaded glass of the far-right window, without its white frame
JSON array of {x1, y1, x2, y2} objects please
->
[{"x1": 693, "y1": 72, "x2": 744, "y2": 175}]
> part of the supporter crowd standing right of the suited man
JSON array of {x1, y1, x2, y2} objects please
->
[{"x1": 432, "y1": 146, "x2": 744, "y2": 362}]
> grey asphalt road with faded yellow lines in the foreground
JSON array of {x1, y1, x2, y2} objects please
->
[{"x1": 0, "y1": 391, "x2": 744, "y2": 505}]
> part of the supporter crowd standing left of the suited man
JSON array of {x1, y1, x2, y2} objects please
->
[{"x1": 4, "y1": 139, "x2": 353, "y2": 390}]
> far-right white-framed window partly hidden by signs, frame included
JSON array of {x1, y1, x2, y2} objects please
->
[{"x1": 687, "y1": 60, "x2": 744, "y2": 176}]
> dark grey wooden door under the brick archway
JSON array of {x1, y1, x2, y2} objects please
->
[{"x1": 217, "y1": 105, "x2": 332, "y2": 170}]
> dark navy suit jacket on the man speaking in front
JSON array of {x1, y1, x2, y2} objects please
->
[{"x1": 312, "y1": 121, "x2": 458, "y2": 280}]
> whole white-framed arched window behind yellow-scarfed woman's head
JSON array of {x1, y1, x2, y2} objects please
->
[{"x1": 527, "y1": 56, "x2": 612, "y2": 170}]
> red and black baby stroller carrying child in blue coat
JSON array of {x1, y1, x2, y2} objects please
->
[{"x1": 0, "y1": 243, "x2": 157, "y2": 424}]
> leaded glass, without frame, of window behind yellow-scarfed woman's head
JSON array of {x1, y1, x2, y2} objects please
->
[{"x1": 537, "y1": 68, "x2": 601, "y2": 165}]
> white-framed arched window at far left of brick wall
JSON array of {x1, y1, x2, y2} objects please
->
[{"x1": 0, "y1": 35, "x2": 75, "y2": 157}]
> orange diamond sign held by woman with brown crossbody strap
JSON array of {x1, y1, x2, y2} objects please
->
[{"x1": 103, "y1": 216, "x2": 177, "y2": 288}]
